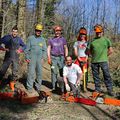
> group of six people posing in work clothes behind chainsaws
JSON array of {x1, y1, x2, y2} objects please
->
[{"x1": 0, "y1": 24, "x2": 113, "y2": 96}]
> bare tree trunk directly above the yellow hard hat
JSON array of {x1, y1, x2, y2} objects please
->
[{"x1": 36, "y1": 0, "x2": 46, "y2": 24}]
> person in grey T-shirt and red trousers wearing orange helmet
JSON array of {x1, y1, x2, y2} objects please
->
[{"x1": 73, "y1": 27, "x2": 88, "y2": 71}]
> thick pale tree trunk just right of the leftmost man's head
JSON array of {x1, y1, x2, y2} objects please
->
[{"x1": 17, "y1": 0, "x2": 26, "y2": 41}]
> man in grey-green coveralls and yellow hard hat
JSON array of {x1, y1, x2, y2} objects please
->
[{"x1": 25, "y1": 24, "x2": 47, "y2": 92}]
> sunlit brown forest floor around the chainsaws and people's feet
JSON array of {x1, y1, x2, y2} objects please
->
[{"x1": 0, "y1": 61, "x2": 120, "y2": 120}]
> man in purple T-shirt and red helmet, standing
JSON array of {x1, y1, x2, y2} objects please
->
[{"x1": 47, "y1": 26, "x2": 68, "y2": 90}]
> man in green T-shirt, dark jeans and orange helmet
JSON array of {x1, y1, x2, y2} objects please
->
[{"x1": 86, "y1": 24, "x2": 114, "y2": 96}]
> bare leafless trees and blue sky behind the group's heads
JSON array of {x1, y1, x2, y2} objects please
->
[{"x1": 0, "y1": 0, "x2": 120, "y2": 43}]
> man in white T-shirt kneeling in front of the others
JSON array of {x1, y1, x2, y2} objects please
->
[{"x1": 63, "y1": 56, "x2": 82, "y2": 96}]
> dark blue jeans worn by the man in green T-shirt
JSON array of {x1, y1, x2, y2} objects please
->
[{"x1": 91, "y1": 62, "x2": 112, "y2": 92}]
